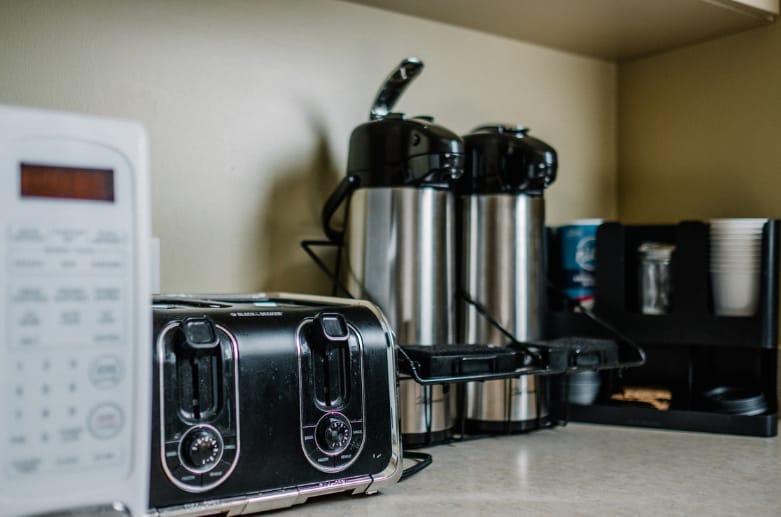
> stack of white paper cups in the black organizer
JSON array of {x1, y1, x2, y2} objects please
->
[{"x1": 710, "y1": 219, "x2": 767, "y2": 316}]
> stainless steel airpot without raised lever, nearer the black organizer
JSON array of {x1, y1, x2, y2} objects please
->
[{"x1": 457, "y1": 124, "x2": 558, "y2": 433}]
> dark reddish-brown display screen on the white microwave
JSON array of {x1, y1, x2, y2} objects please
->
[{"x1": 20, "y1": 163, "x2": 114, "y2": 202}]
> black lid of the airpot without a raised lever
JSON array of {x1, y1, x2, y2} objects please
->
[{"x1": 457, "y1": 124, "x2": 558, "y2": 195}]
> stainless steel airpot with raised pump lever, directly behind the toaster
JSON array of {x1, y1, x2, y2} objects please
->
[{"x1": 322, "y1": 58, "x2": 464, "y2": 444}]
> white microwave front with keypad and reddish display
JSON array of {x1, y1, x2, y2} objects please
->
[{"x1": 0, "y1": 104, "x2": 151, "y2": 515}]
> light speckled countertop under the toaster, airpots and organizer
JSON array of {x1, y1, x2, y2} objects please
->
[{"x1": 272, "y1": 423, "x2": 781, "y2": 517}]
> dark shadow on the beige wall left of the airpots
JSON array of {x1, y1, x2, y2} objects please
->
[{"x1": 258, "y1": 115, "x2": 342, "y2": 295}]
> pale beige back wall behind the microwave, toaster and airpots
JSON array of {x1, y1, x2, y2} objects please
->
[{"x1": 0, "y1": 0, "x2": 616, "y2": 291}]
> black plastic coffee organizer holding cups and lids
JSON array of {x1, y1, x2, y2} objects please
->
[{"x1": 546, "y1": 219, "x2": 779, "y2": 436}]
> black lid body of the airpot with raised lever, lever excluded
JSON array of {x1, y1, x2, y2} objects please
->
[{"x1": 347, "y1": 113, "x2": 464, "y2": 187}]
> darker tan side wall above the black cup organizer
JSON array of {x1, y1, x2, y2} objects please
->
[{"x1": 618, "y1": 16, "x2": 781, "y2": 222}]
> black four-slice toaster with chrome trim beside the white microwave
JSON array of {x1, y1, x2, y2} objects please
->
[{"x1": 149, "y1": 294, "x2": 401, "y2": 516}]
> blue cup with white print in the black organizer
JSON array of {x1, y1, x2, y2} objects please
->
[{"x1": 558, "y1": 219, "x2": 602, "y2": 308}]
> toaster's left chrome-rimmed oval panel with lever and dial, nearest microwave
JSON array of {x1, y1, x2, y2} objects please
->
[{"x1": 153, "y1": 316, "x2": 239, "y2": 493}]
